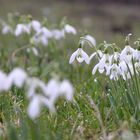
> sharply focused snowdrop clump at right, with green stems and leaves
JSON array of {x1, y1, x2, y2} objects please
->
[{"x1": 69, "y1": 34, "x2": 140, "y2": 131}]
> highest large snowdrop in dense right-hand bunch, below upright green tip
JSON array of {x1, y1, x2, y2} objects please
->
[{"x1": 120, "y1": 45, "x2": 135, "y2": 63}]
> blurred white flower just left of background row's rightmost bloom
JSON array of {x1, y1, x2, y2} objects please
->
[{"x1": 51, "y1": 29, "x2": 65, "y2": 40}]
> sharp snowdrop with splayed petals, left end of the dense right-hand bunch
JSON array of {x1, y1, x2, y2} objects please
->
[{"x1": 92, "y1": 54, "x2": 112, "y2": 75}]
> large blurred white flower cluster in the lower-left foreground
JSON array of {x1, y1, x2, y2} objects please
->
[{"x1": 0, "y1": 68, "x2": 74, "y2": 119}]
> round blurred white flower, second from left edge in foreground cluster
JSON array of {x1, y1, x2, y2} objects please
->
[{"x1": 8, "y1": 68, "x2": 27, "y2": 88}]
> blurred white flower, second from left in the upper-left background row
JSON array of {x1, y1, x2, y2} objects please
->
[{"x1": 15, "y1": 24, "x2": 30, "y2": 36}]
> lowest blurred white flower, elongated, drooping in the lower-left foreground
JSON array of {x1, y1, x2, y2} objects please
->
[{"x1": 27, "y1": 95, "x2": 42, "y2": 119}]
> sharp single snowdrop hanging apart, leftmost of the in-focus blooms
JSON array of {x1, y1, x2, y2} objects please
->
[{"x1": 69, "y1": 48, "x2": 90, "y2": 64}]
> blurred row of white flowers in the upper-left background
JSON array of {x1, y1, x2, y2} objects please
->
[{"x1": 1, "y1": 17, "x2": 77, "y2": 46}]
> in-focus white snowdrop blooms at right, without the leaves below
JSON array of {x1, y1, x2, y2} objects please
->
[{"x1": 69, "y1": 34, "x2": 140, "y2": 80}]
